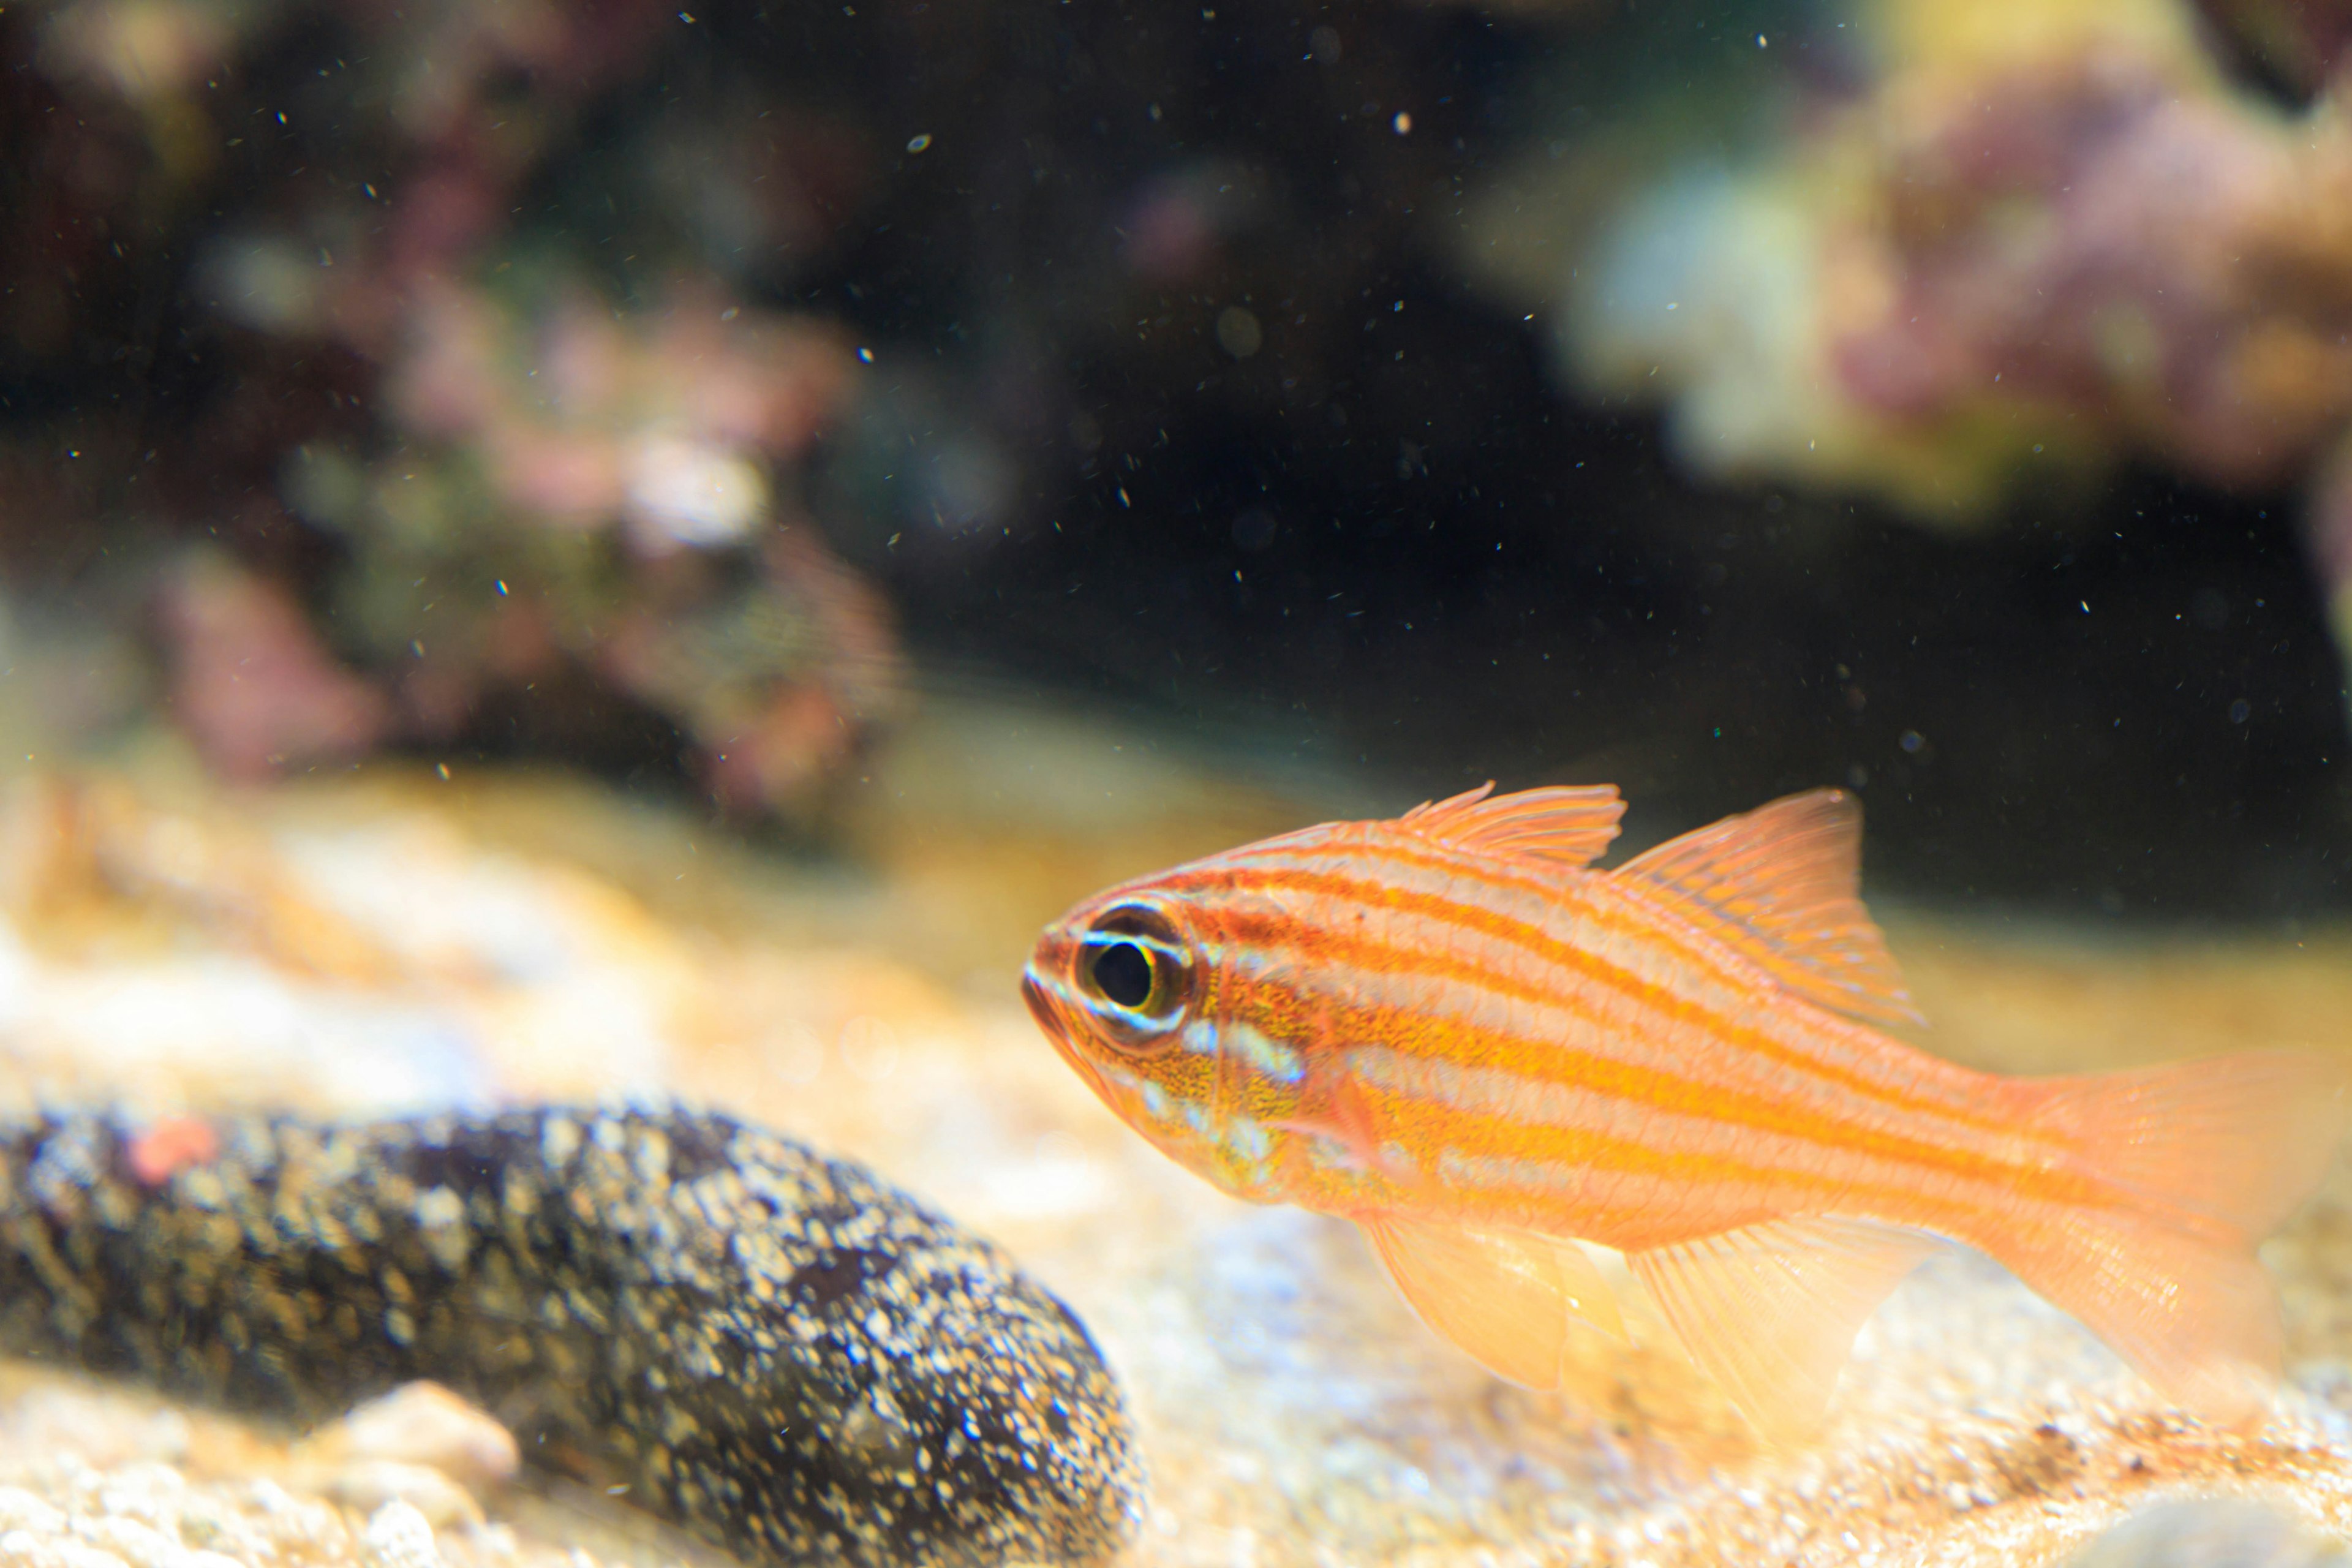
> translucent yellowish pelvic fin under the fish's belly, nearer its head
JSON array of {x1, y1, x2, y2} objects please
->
[{"x1": 1357, "y1": 1215, "x2": 1625, "y2": 1389}]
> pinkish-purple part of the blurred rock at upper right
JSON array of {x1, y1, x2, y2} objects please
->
[{"x1": 1832, "y1": 54, "x2": 2352, "y2": 484}]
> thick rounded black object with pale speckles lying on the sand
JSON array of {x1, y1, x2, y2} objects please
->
[{"x1": 0, "y1": 1110, "x2": 1143, "y2": 1563}]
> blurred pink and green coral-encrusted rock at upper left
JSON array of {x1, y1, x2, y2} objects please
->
[{"x1": 0, "y1": 0, "x2": 896, "y2": 813}]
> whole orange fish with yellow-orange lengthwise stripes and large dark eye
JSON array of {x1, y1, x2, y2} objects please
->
[{"x1": 1021, "y1": 785, "x2": 2352, "y2": 1441}]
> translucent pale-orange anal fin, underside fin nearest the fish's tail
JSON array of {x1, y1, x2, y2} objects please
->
[{"x1": 1625, "y1": 1215, "x2": 1940, "y2": 1444}]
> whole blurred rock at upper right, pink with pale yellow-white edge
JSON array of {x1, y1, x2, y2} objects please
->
[{"x1": 1468, "y1": 0, "x2": 2352, "y2": 682}]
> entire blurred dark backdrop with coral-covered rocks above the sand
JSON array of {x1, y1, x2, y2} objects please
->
[{"x1": 0, "y1": 0, "x2": 2352, "y2": 917}]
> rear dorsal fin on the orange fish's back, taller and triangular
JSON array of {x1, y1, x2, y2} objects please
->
[{"x1": 1616, "y1": 790, "x2": 1924, "y2": 1023}]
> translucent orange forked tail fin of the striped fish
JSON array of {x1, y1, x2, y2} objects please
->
[{"x1": 1971, "y1": 1051, "x2": 2352, "y2": 1425}]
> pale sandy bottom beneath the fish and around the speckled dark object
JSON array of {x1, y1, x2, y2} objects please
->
[{"x1": 0, "y1": 705, "x2": 2352, "y2": 1568}]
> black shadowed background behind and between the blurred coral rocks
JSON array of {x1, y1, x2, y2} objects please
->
[{"x1": 0, "y1": 0, "x2": 2352, "y2": 919}]
